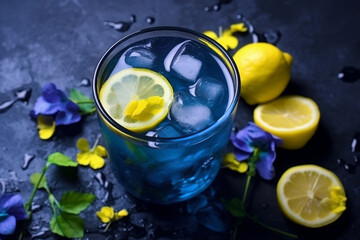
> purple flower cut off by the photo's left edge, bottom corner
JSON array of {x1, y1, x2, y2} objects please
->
[{"x1": 0, "y1": 194, "x2": 27, "y2": 236}]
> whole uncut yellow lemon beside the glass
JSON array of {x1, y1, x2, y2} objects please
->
[{"x1": 233, "y1": 43, "x2": 292, "y2": 105}]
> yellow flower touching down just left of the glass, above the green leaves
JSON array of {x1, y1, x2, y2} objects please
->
[{"x1": 76, "y1": 137, "x2": 107, "y2": 169}]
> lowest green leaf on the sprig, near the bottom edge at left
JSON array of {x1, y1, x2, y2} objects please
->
[{"x1": 50, "y1": 211, "x2": 85, "y2": 238}]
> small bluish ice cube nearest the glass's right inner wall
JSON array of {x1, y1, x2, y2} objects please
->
[{"x1": 194, "y1": 77, "x2": 226, "y2": 107}]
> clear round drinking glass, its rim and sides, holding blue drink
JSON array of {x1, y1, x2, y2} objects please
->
[{"x1": 93, "y1": 27, "x2": 240, "y2": 204}]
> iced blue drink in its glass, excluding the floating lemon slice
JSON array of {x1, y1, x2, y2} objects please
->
[{"x1": 93, "y1": 27, "x2": 240, "y2": 204}]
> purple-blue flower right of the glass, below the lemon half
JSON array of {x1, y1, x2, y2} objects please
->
[{"x1": 230, "y1": 122, "x2": 282, "y2": 180}]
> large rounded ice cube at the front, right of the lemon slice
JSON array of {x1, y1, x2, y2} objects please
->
[{"x1": 170, "y1": 92, "x2": 214, "y2": 134}]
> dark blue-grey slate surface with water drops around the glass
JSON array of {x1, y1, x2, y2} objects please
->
[{"x1": 0, "y1": 0, "x2": 360, "y2": 239}]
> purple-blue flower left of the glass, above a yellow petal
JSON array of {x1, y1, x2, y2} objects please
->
[{"x1": 30, "y1": 83, "x2": 81, "y2": 126}]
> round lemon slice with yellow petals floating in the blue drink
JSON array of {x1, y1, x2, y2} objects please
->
[{"x1": 99, "y1": 68, "x2": 173, "y2": 132}]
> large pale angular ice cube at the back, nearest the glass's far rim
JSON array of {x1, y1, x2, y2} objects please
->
[{"x1": 164, "y1": 41, "x2": 202, "y2": 83}]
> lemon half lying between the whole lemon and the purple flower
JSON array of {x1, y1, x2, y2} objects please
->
[{"x1": 254, "y1": 95, "x2": 320, "y2": 149}]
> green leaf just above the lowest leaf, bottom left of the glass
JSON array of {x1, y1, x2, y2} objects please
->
[{"x1": 60, "y1": 191, "x2": 95, "y2": 214}]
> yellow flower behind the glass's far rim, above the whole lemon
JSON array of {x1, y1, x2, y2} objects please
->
[{"x1": 204, "y1": 23, "x2": 247, "y2": 50}]
